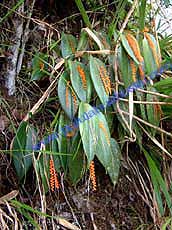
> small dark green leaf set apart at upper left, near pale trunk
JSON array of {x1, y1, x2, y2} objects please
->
[{"x1": 31, "y1": 53, "x2": 48, "y2": 81}]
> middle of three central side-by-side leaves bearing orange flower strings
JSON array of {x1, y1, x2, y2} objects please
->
[{"x1": 68, "y1": 61, "x2": 91, "y2": 102}]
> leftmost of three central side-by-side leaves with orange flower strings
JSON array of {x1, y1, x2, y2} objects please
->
[{"x1": 58, "y1": 71, "x2": 78, "y2": 119}]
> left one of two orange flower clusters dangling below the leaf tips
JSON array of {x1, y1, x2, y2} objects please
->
[{"x1": 50, "y1": 158, "x2": 60, "y2": 192}]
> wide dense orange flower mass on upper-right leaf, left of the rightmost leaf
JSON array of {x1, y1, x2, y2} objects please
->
[{"x1": 126, "y1": 34, "x2": 144, "y2": 62}]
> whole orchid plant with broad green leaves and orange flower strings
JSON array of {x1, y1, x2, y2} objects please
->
[{"x1": 11, "y1": 28, "x2": 168, "y2": 196}]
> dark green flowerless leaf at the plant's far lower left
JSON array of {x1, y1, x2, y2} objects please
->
[{"x1": 11, "y1": 122, "x2": 37, "y2": 181}]
